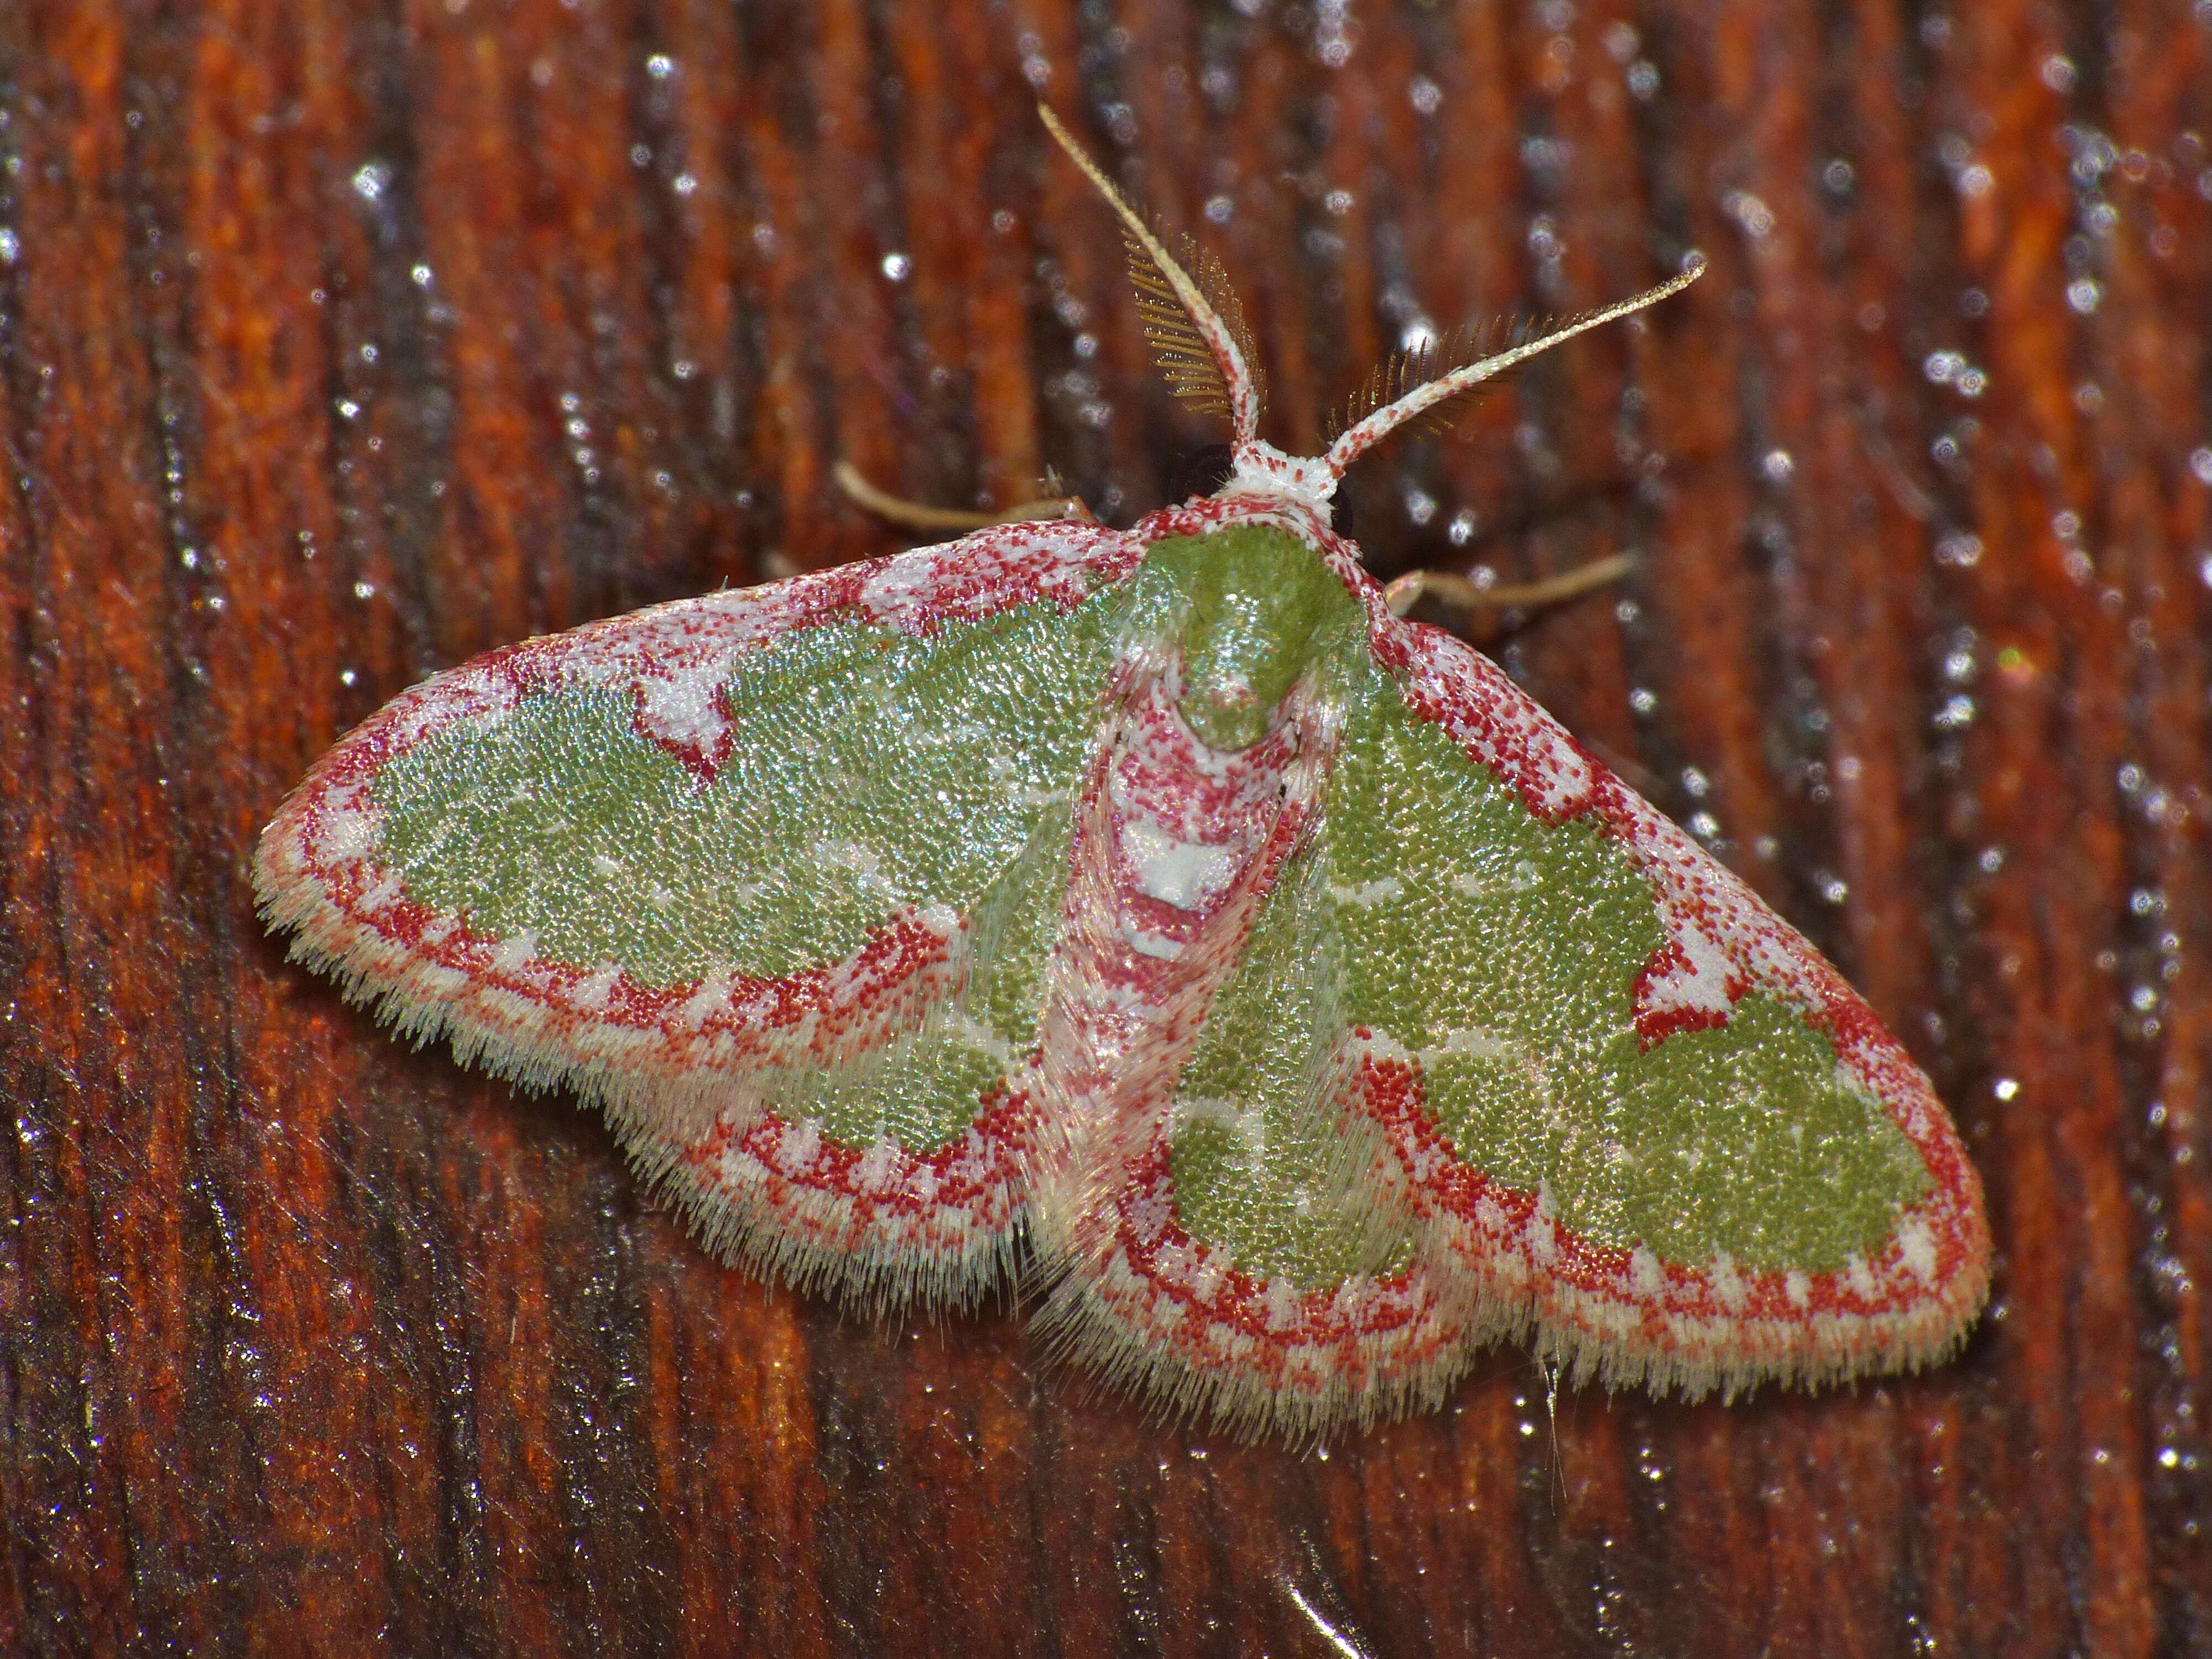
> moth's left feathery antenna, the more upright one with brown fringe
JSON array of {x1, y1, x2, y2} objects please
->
[{"x1": 1037, "y1": 104, "x2": 1261, "y2": 445}]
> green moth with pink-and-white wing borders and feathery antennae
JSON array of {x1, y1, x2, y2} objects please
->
[{"x1": 254, "y1": 111, "x2": 1989, "y2": 1440}]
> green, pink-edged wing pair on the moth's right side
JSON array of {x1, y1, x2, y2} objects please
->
[{"x1": 1046, "y1": 619, "x2": 1989, "y2": 1438}]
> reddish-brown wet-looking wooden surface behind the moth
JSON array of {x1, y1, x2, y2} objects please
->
[{"x1": 0, "y1": 0, "x2": 2212, "y2": 1659}]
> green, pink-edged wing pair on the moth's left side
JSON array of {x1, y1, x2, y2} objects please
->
[{"x1": 254, "y1": 522, "x2": 1137, "y2": 1301}]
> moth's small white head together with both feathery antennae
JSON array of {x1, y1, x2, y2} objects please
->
[{"x1": 1037, "y1": 104, "x2": 1705, "y2": 518}]
